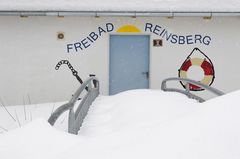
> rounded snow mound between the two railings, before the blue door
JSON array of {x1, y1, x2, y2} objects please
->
[{"x1": 81, "y1": 90, "x2": 199, "y2": 136}]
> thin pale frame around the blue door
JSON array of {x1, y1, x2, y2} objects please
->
[{"x1": 107, "y1": 33, "x2": 152, "y2": 95}]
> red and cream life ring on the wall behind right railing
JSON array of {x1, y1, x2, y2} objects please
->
[{"x1": 179, "y1": 58, "x2": 215, "y2": 91}]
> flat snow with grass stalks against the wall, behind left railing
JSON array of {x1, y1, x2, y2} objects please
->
[{"x1": 0, "y1": 102, "x2": 68, "y2": 133}]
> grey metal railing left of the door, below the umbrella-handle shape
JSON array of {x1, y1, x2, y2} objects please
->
[{"x1": 48, "y1": 77, "x2": 99, "y2": 134}]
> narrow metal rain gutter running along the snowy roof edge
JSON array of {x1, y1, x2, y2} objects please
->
[{"x1": 0, "y1": 11, "x2": 240, "y2": 17}]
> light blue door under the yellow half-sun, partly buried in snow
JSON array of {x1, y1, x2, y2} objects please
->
[{"x1": 109, "y1": 35, "x2": 150, "y2": 95}]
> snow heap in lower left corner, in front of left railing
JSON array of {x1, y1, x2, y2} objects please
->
[{"x1": 0, "y1": 119, "x2": 80, "y2": 159}]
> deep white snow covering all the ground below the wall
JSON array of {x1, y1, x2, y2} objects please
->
[{"x1": 0, "y1": 90, "x2": 240, "y2": 159}]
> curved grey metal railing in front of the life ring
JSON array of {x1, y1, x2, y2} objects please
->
[{"x1": 161, "y1": 77, "x2": 225, "y2": 102}]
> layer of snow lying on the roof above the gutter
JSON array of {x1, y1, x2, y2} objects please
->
[{"x1": 0, "y1": 0, "x2": 240, "y2": 12}]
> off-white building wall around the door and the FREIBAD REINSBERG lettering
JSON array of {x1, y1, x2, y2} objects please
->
[{"x1": 0, "y1": 16, "x2": 240, "y2": 105}]
